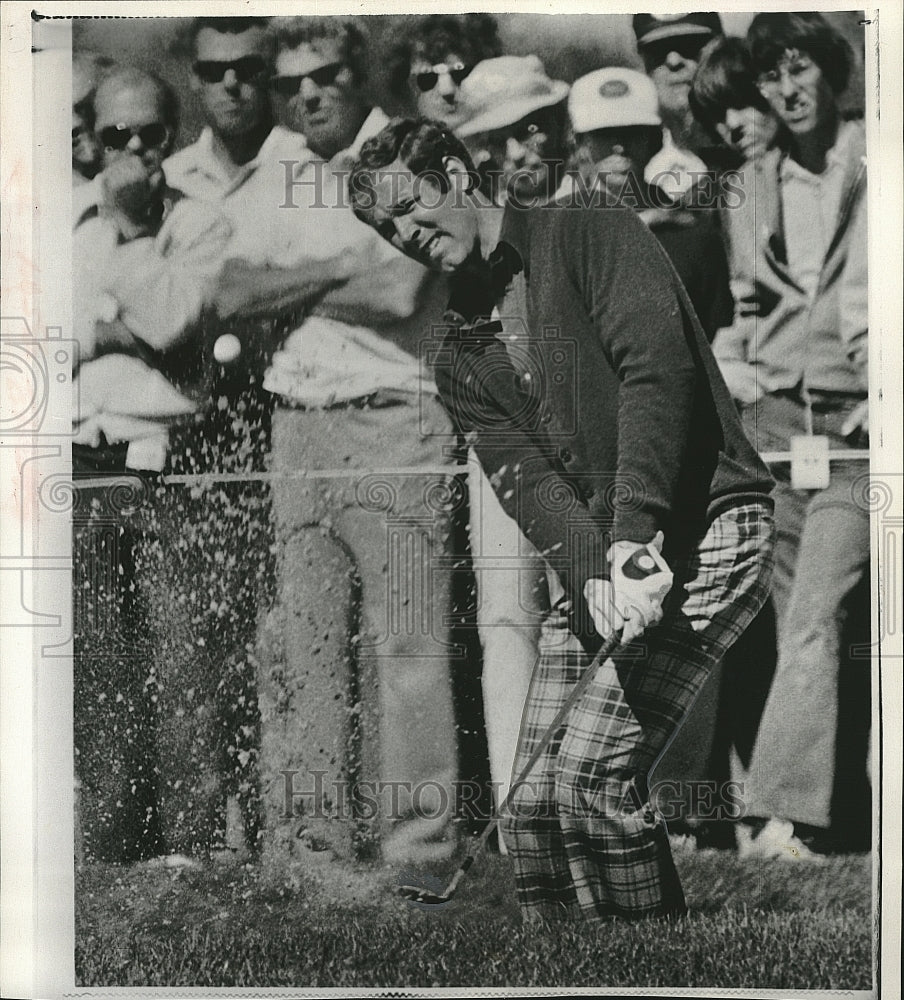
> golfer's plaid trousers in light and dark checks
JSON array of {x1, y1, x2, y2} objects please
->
[{"x1": 503, "y1": 500, "x2": 774, "y2": 919}]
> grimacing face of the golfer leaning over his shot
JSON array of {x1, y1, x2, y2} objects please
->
[{"x1": 368, "y1": 160, "x2": 478, "y2": 273}]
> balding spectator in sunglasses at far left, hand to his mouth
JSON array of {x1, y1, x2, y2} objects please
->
[{"x1": 73, "y1": 68, "x2": 229, "y2": 860}]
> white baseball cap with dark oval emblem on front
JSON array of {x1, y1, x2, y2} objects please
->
[{"x1": 568, "y1": 66, "x2": 662, "y2": 134}]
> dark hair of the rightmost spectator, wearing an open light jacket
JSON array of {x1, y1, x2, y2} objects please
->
[{"x1": 747, "y1": 11, "x2": 854, "y2": 94}]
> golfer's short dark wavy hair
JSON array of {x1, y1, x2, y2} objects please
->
[{"x1": 349, "y1": 118, "x2": 479, "y2": 221}]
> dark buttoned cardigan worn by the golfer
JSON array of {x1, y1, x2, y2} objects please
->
[{"x1": 436, "y1": 207, "x2": 772, "y2": 620}]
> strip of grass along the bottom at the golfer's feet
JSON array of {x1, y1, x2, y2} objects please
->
[{"x1": 76, "y1": 836, "x2": 872, "y2": 989}]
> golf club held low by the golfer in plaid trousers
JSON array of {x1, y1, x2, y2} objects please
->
[{"x1": 396, "y1": 544, "x2": 672, "y2": 907}]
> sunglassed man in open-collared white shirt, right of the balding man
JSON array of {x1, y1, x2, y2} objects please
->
[{"x1": 165, "y1": 17, "x2": 332, "y2": 849}]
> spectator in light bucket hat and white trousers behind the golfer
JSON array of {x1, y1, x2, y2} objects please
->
[{"x1": 456, "y1": 56, "x2": 568, "y2": 852}]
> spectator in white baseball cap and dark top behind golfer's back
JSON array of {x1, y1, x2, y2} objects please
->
[{"x1": 562, "y1": 66, "x2": 733, "y2": 340}]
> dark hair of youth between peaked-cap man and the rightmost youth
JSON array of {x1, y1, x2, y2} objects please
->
[{"x1": 688, "y1": 36, "x2": 770, "y2": 138}]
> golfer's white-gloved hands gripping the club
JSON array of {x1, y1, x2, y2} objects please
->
[{"x1": 584, "y1": 531, "x2": 672, "y2": 643}]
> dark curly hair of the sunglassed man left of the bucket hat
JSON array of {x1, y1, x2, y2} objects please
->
[{"x1": 387, "y1": 14, "x2": 502, "y2": 97}]
